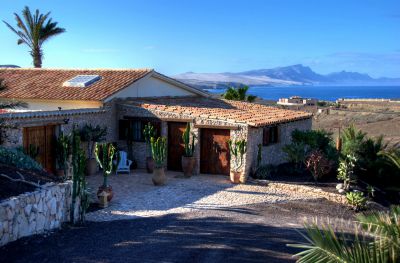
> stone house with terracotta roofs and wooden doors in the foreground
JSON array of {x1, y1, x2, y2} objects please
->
[{"x1": 0, "y1": 68, "x2": 311, "y2": 179}]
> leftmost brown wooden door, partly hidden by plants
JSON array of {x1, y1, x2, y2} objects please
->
[{"x1": 23, "y1": 125, "x2": 56, "y2": 173}]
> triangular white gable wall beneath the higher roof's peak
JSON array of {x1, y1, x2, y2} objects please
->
[{"x1": 107, "y1": 76, "x2": 196, "y2": 101}]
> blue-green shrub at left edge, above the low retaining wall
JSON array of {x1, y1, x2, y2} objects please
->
[{"x1": 0, "y1": 146, "x2": 43, "y2": 171}]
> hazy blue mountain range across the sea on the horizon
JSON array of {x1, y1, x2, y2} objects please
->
[{"x1": 173, "y1": 64, "x2": 400, "y2": 88}]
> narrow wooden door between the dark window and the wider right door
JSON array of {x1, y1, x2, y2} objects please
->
[{"x1": 168, "y1": 122, "x2": 186, "y2": 171}]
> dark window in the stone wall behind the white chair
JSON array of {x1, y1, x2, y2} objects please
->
[{"x1": 119, "y1": 118, "x2": 161, "y2": 142}]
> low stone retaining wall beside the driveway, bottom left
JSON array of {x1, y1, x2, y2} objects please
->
[{"x1": 0, "y1": 181, "x2": 79, "y2": 246}]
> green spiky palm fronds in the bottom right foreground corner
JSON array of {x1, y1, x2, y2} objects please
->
[{"x1": 288, "y1": 206, "x2": 400, "y2": 263}]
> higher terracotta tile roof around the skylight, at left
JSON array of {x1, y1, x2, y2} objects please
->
[{"x1": 0, "y1": 68, "x2": 153, "y2": 101}]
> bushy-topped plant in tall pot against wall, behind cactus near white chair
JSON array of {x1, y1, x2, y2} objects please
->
[{"x1": 80, "y1": 124, "x2": 107, "y2": 175}]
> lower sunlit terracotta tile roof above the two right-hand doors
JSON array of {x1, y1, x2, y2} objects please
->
[{"x1": 121, "y1": 97, "x2": 312, "y2": 127}]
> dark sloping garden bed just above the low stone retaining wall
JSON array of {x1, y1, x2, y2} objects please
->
[{"x1": 0, "y1": 164, "x2": 62, "y2": 200}]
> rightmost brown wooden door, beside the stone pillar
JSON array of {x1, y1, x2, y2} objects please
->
[{"x1": 200, "y1": 129, "x2": 230, "y2": 175}]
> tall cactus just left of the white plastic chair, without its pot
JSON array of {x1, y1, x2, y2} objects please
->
[{"x1": 94, "y1": 142, "x2": 116, "y2": 187}]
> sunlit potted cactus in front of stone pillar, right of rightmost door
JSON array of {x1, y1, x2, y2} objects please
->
[{"x1": 228, "y1": 140, "x2": 247, "y2": 184}]
